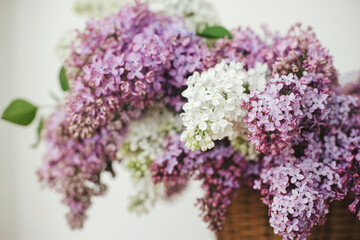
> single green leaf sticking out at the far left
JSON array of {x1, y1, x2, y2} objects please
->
[{"x1": 1, "y1": 99, "x2": 38, "y2": 126}]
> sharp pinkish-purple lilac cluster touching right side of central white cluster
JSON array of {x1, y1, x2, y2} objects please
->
[{"x1": 244, "y1": 73, "x2": 329, "y2": 155}]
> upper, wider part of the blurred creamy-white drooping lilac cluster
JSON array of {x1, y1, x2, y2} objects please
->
[{"x1": 117, "y1": 108, "x2": 182, "y2": 180}]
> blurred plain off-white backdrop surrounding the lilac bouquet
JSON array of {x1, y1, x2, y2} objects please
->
[{"x1": 0, "y1": 0, "x2": 360, "y2": 240}]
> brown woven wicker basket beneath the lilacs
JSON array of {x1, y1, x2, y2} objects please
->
[{"x1": 217, "y1": 187, "x2": 360, "y2": 240}]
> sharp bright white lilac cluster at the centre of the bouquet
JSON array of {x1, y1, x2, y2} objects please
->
[{"x1": 181, "y1": 61, "x2": 268, "y2": 151}]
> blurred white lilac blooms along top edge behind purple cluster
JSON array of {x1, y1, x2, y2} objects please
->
[{"x1": 75, "y1": 0, "x2": 219, "y2": 31}]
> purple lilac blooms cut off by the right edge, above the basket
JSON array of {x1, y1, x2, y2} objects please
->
[{"x1": 324, "y1": 92, "x2": 360, "y2": 220}]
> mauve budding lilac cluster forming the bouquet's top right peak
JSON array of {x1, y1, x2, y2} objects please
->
[{"x1": 265, "y1": 24, "x2": 337, "y2": 85}]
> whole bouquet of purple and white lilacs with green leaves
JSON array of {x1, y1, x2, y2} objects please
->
[{"x1": 3, "y1": 1, "x2": 360, "y2": 239}]
